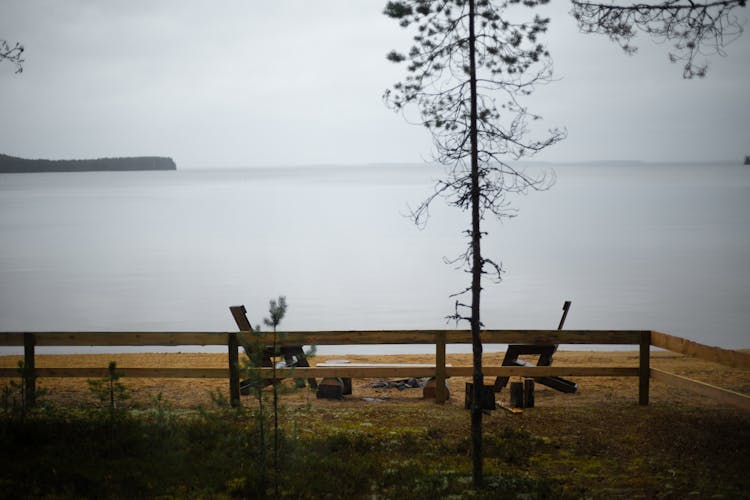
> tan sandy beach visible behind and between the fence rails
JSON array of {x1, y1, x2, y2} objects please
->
[{"x1": 0, "y1": 351, "x2": 750, "y2": 408}]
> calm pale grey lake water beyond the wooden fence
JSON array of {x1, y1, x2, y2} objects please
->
[{"x1": 0, "y1": 164, "x2": 750, "y2": 353}]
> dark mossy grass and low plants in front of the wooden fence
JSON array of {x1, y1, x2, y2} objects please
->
[{"x1": 0, "y1": 398, "x2": 750, "y2": 499}]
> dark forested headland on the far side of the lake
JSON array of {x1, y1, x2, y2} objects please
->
[{"x1": 0, "y1": 154, "x2": 177, "y2": 174}]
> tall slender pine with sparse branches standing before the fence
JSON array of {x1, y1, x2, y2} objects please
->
[{"x1": 385, "y1": 0, "x2": 564, "y2": 487}]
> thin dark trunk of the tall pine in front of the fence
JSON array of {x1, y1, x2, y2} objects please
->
[{"x1": 469, "y1": 0, "x2": 484, "y2": 488}]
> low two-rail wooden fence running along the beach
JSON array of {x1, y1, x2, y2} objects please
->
[{"x1": 0, "y1": 330, "x2": 750, "y2": 410}]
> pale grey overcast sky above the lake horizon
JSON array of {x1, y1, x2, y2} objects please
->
[{"x1": 0, "y1": 0, "x2": 750, "y2": 168}]
